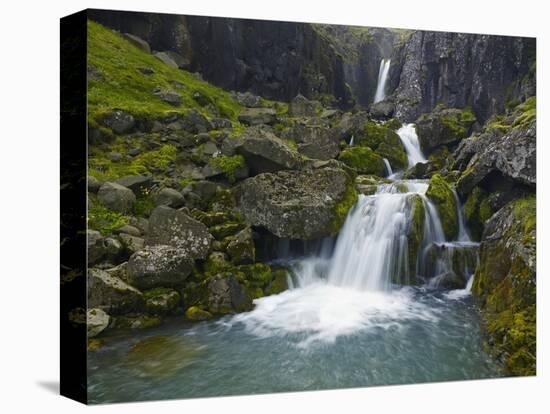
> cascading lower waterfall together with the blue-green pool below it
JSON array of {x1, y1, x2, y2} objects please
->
[{"x1": 88, "y1": 125, "x2": 502, "y2": 403}]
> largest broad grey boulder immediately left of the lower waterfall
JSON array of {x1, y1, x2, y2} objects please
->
[{"x1": 236, "y1": 168, "x2": 357, "y2": 240}]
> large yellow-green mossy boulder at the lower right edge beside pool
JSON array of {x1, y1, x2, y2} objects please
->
[{"x1": 472, "y1": 196, "x2": 537, "y2": 376}]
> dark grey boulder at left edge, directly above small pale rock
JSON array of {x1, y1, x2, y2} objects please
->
[{"x1": 88, "y1": 268, "x2": 143, "y2": 314}]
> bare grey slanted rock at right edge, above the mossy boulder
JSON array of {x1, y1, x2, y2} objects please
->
[{"x1": 457, "y1": 121, "x2": 537, "y2": 197}]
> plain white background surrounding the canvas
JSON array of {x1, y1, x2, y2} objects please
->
[{"x1": 0, "y1": 0, "x2": 550, "y2": 414}]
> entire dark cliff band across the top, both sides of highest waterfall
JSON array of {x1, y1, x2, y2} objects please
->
[{"x1": 90, "y1": 10, "x2": 535, "y2": 122}]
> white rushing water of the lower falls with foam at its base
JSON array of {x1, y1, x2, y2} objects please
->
[{"x1": 233, "y1": 122, "x2": 476, "y2": 346}]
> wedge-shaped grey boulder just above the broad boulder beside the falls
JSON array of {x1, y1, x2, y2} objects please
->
[{"x1": 232, "y1": 127, "x2": 304, "y2": 174}]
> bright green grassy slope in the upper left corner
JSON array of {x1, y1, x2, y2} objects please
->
[{"x1": 88, "y1": 21, "x2": 242, "y2": 123}]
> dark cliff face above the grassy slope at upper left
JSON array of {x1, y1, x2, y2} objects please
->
[{"x1": 90, "y1": 10, "x2": 353, "y2": 107}]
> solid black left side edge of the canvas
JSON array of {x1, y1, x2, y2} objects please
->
[{"x1": 60, "y1": 10, "x2": 88, "y2": 404}]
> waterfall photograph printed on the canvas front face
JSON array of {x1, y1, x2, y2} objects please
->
[{"x1": 62, "y1": 10, "x2": 536, "y2": 404}]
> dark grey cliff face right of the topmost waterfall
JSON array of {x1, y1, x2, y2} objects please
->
[{"x1": 394, "y1": 31, "x2": 535, "y2": 122}]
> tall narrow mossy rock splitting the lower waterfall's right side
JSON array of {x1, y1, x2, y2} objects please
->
[{"x1": 426, "y1": 174, "x2": 458, "y2": 240}]
